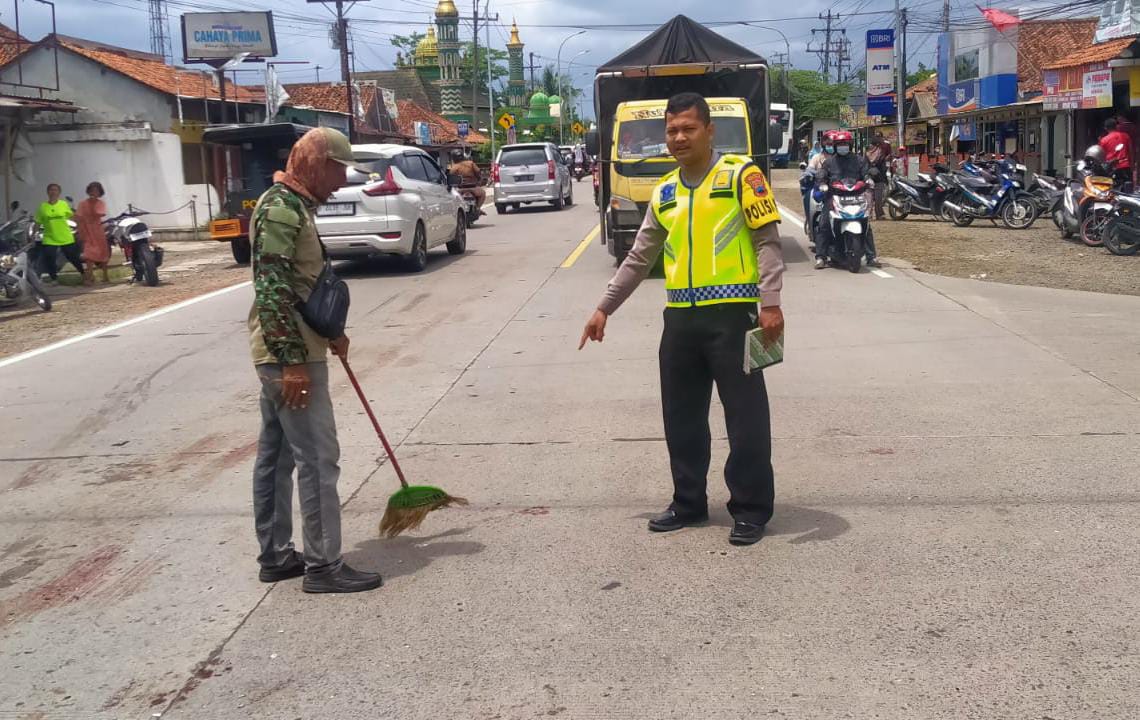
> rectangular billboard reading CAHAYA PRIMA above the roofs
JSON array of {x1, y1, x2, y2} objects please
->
[{"x1": 182, "y1": 11, "x2": 277, "y2": 63}]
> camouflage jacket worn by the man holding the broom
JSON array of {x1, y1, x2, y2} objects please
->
[{"x1": 249, "y1": 183, "x2": 328, "y2": 365}]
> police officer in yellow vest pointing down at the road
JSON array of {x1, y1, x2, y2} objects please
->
[{"x1": 578, "y1": 92, "x2": 784, "y2": 545}]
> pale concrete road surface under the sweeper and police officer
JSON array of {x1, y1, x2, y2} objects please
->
[{"x1": 0, "y1": 191, "x2": 1140, "y2": 720}]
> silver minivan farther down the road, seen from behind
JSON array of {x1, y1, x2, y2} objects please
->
[{"x1": 491, "y1": 142, "x2": 573, "y2": 215}]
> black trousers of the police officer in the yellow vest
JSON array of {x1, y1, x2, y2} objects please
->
[{"x1": 660, "y1": 303, "x2": 775, "y2": 524}]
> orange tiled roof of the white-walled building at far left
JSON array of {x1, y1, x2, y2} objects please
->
[{"x1": 47, "y1": 35, "x2": 266, "y2": 103}]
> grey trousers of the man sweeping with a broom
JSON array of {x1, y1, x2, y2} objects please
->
[{"x1": 253, "y1": 362, "x2": 341, "y2": 570}]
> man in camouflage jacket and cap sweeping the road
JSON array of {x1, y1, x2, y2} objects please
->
[{"x1": 250, "y1": 128, "x2": 382, "y2": 592}]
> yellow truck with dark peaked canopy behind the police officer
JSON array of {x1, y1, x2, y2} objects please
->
[{"x1": 586, "y1": 15, "x2": 773, "y2": 262}]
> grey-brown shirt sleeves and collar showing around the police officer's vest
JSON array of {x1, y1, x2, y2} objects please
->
[{"x1": 597, "y1": 153, "x2": 784, "y2": 316}]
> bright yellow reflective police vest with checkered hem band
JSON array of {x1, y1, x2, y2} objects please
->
[{"x1": 650, "y1": 155, "x2": 780, "y2": 308}]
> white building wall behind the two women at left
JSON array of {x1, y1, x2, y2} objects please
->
[{"x1": 0, "y1": 132, "x2": 220, "y2": 229}]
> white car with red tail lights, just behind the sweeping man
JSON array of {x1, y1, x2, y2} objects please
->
[{"x1": 317, "y1": 145, "x2": 467, "y2": 272}]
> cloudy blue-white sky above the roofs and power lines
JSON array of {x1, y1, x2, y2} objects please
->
[{"x1": 8, "y1": 0, "x2": 957, "y2": 113}]
